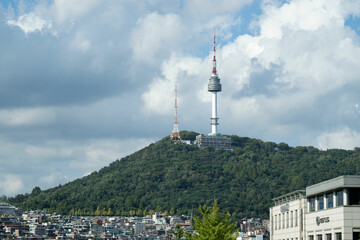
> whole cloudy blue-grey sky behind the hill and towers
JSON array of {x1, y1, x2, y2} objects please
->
[{"x1": 0, "y1": 0, "x2": 360, "y2": 196}]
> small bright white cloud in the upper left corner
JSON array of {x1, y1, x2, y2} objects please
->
[{"x1": 7, "y1": 13, "x2": 52, "y2": 33}]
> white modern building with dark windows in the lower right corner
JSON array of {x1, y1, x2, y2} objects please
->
[{"x1": 270, "y1": 176, "x2": 360, "y2": 240}]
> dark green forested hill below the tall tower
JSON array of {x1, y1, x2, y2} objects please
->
[{"x1": 9, "y1": 132, "x2": 360, "y2": 217}]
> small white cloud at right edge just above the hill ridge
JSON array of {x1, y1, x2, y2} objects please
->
[{"x1": 316, "y1": 127, "x2": 360, "y2": 150}]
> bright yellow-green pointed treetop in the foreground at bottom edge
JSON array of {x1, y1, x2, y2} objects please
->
[{"x1": 188, "y1": 201, "x2": 237, "y2": 240}]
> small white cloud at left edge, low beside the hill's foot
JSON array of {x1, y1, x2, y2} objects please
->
[{"x1": 0, "y1": 174, "x2": 24, "y2": 196}]
